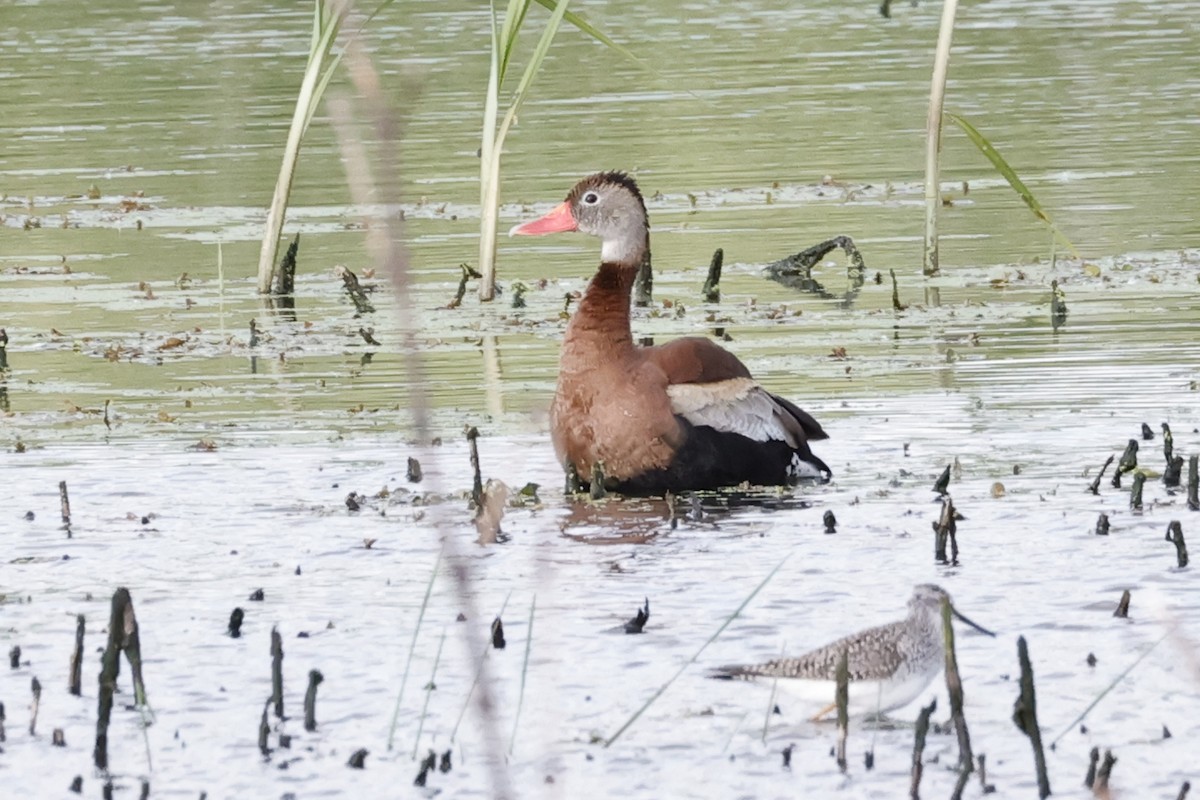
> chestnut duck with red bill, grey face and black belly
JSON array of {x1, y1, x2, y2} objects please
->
[{"x1": 510, "y1": 172, "x2": 830, "y2": 494}]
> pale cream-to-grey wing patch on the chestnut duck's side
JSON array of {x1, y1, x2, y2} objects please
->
[{"x1": 667, "y1": 378, "x2": 797, "y2": 447}]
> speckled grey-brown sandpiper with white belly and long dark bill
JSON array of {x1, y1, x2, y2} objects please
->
[{"x1": 710, "y1": 583, "x2": 996, "y2": 721}]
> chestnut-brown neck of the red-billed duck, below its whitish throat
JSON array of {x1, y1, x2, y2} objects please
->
[{"x1": 563, "y1": 257, "x2": 641, "y2": 371}]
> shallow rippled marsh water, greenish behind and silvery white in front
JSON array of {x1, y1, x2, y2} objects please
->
[{"x1": 0, "y1": 0, "x2": 1200, "y2": 798}]
